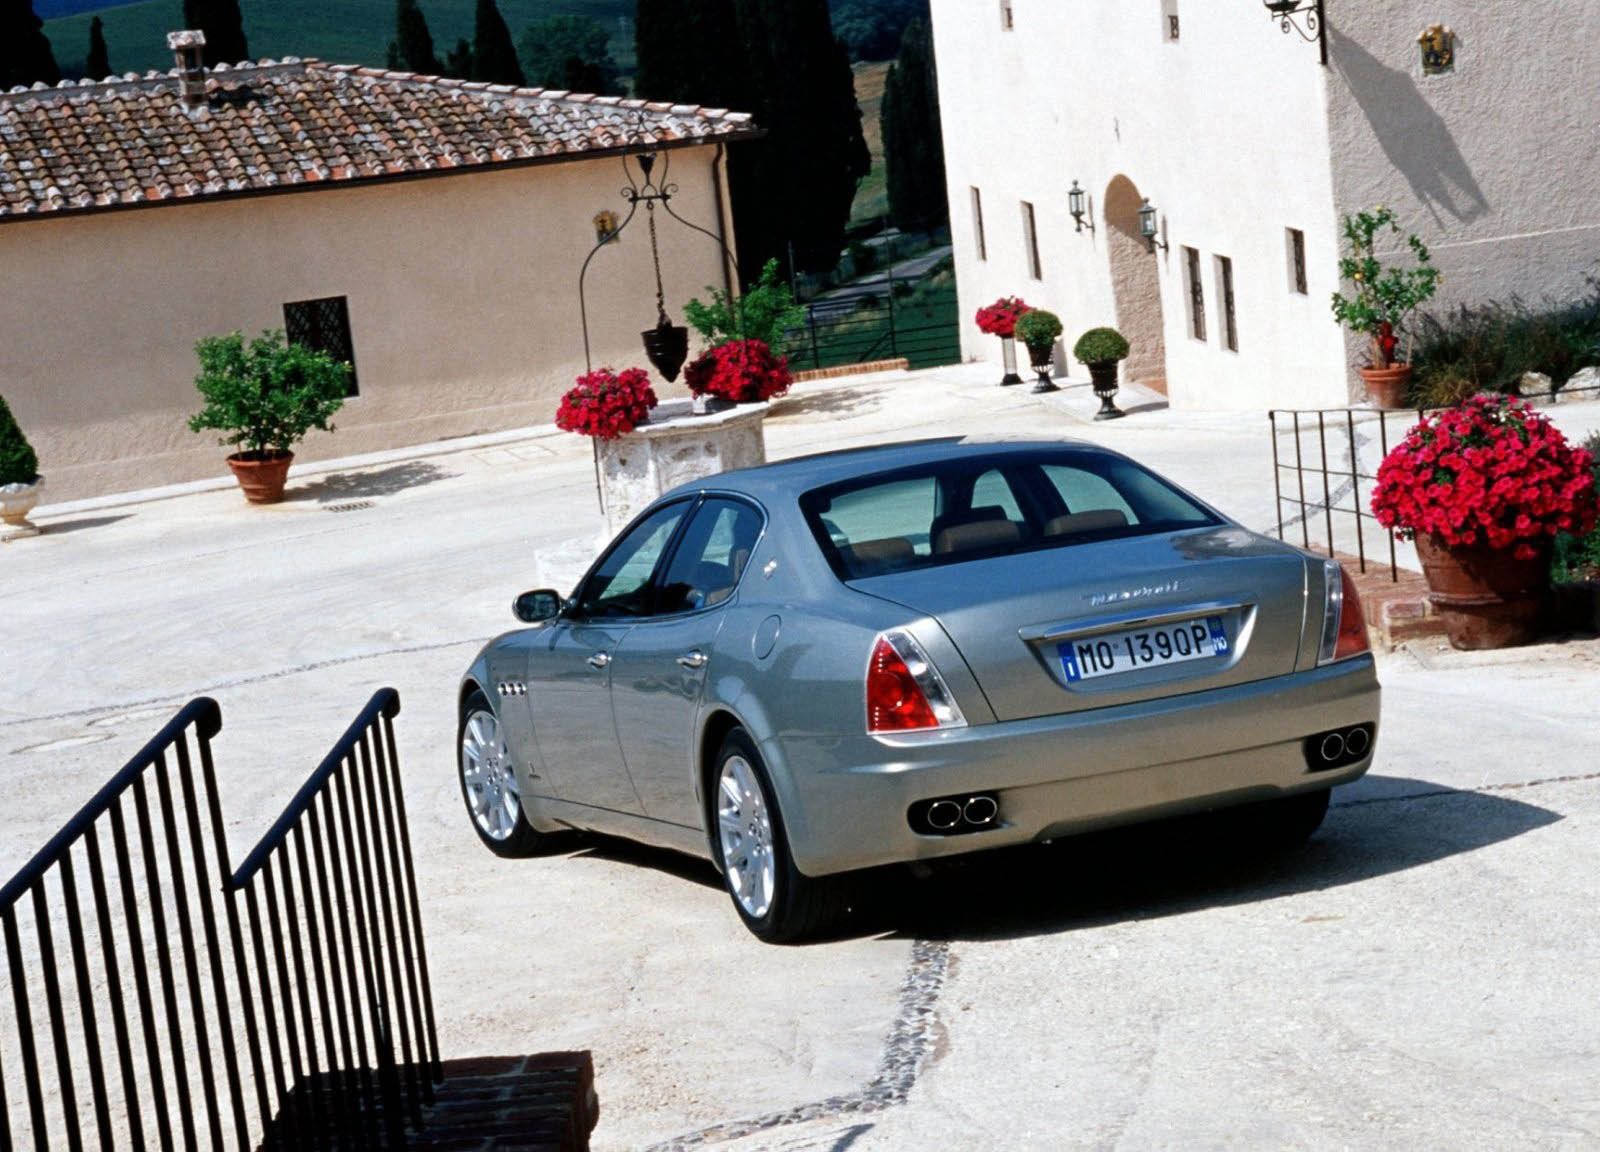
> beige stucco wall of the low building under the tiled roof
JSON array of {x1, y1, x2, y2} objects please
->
[{"x1": 0, "y1": 147, "x2": 736, "y2": 501}]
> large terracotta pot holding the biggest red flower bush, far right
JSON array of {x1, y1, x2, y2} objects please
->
[{"x1": 1416, "y1": 534, "x2": 1550, "y2": 650}]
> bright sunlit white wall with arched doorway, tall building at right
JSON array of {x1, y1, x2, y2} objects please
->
[{"x1": 933, "y1": 0, "x2": 1350, "y2": 408}]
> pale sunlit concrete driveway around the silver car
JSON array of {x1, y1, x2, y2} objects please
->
[{"x1": 0, "y1": 366, "x2": 1600, "y2": 1150}]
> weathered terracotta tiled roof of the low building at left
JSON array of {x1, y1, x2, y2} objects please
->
[{"x1": 0, "y1": 58, "x2": 755, "y2": 221}]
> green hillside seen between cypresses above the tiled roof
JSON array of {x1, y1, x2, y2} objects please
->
[{"x1": 45, "y1": 0, "x2": 634, "y2": 74}]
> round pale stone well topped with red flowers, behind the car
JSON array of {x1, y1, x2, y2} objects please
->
[{"x1": 594, "y1": 400, "x2": 768, "y2": 536}]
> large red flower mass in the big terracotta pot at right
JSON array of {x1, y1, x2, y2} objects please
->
[{"x1": 1373, "y1": 394, "x2": 1595, "y2": 560}]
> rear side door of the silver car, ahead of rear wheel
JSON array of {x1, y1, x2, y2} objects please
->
[{"x1": 611, "y1": 496, "x2": 765, "y2": 827}]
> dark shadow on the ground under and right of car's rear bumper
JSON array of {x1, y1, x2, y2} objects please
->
[{"x1": 848, "y1": 776, "x2": 1562, "y2": 939}]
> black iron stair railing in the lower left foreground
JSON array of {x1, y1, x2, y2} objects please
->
[{"x1": 0, "y1": 688, "x2": 440, "y2": 1152}]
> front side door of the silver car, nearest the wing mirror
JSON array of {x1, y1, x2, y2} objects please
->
[{"x1": 528, "y1": 501, "x2": 691, "y2": 816}]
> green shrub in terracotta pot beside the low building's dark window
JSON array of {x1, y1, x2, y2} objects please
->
[{"x1": 189, "y1": 331, "x2": 350, "y2": 504}]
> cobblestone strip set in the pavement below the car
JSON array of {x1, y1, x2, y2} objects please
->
[{"x1": 648, "y1": 941, "x2": 950, "y2": 1152}]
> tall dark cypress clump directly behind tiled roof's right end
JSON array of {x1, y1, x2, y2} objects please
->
[{"x1": 635, "y1": 0, "x2": 872, "y2": 282}]
